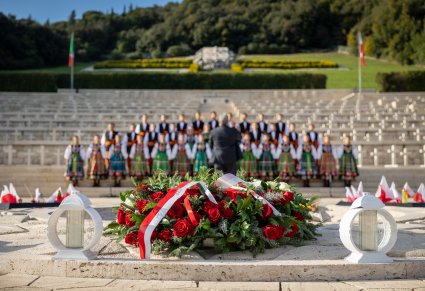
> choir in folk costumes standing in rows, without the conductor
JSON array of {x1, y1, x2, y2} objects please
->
[{"x1": 65, "y1": 112, "x2": 358, "y2": 186}]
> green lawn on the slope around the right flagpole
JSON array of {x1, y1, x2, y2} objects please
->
[{"x1": 243, "y1": 53, "x2": 424, "y2": 89}]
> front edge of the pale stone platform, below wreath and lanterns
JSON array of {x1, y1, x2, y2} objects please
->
[{"x1": 0, "y1": 255, "x2": 425, "y2": 282}]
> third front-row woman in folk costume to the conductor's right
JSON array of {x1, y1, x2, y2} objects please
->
[{"x1": 274, "y1": 135, "x2": 297, "y2": 181}]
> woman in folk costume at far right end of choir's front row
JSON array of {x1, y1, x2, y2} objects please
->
[{"x1": 338, "y1": 136, "x2": 359, "y2": 187}]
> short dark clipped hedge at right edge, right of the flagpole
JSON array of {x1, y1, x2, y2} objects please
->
[{"x1": 376, "y1": 71, "x2": 425, "y2": 92}]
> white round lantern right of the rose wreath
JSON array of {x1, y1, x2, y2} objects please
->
[{"x1": 339, "y1": 193, "x2": 397, "y2": 263}]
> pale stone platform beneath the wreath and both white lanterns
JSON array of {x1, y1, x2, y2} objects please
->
[{"x1": 0, "y1": 198, "x2": 425, "y2": 290}]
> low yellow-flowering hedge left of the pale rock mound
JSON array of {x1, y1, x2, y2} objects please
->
[{"x1": 94, "y1": 59, "x2": 192, "y2": 69}]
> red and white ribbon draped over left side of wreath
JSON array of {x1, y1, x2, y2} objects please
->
[{"x1": 138, "y1": 181, "x2": 217, "y2": 259}]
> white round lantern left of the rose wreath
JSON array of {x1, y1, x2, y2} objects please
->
[{"x1": 47, "y1": 191, "x2": 103, "y2": 260}]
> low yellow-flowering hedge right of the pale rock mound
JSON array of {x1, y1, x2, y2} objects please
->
[{"x1": 237, "y1": 59, "x2": 338, "y2": 69}]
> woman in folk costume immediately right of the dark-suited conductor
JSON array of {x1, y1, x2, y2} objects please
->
[{"x1": 239, "y1": 133, "x2": 258, "y2": 178}]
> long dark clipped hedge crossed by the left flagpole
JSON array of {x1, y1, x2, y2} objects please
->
[{"x1": 0, "y1": 72, "x2": 326, "y2": 92}]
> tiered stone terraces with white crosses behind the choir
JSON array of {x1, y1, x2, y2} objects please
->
[{"x1": 0, "y1": 90, "x2": 425, "y2": 196}]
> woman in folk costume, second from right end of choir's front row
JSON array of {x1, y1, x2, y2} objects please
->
[{"x1": 317, "y1": 135, "x2": 338, "y2": 187}]
